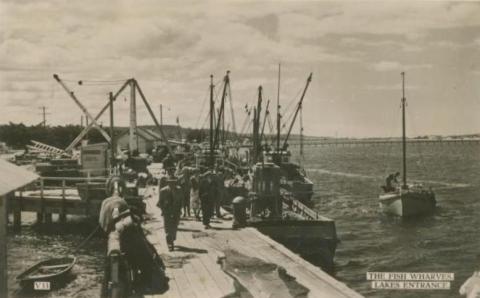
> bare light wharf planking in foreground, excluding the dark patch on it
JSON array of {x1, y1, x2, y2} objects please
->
[{"x1": 144, "y1": 190, "x2": 362, "y2": 298}]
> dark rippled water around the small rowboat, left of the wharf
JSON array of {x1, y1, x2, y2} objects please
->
[{"x1": 7, "y1": 217, "x2": 106, "y2": 298}]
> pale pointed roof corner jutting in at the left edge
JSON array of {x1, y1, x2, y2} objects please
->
[{"x1": 0, "y1": 159, "x2": 38, "y2": 196}]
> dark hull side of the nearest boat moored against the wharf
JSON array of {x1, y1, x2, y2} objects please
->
[{"x1": 250, "y1": 219, "x2": 338, "y2": 273}]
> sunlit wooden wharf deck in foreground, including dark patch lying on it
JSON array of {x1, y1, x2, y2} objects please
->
[{"x1": 144, "y1": 189, "x2": 362, "y2": 298}]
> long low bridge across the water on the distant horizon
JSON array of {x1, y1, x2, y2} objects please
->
[{"x1": 289, "y1": 138, "x2": 480, "y2": 147}]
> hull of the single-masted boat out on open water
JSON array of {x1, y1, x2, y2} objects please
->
[{"x1": 379, "y1": 191, "x2": 436, "y2": 217}]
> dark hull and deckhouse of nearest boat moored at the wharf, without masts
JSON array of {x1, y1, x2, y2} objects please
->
[{"x1": 248, "y1": 162, "x2": 339, "y2": 273}]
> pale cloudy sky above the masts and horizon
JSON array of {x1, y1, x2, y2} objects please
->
[{"x1": 0, "y1": 0, "x2": 480, "y2": 137}]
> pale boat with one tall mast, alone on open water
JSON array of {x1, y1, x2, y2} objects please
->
[{"x1": 379, "y1": 72, "x2": 437, "y2": 217}]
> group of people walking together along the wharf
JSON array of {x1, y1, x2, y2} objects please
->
[{"x1": 157, "y1": 166, "x2": 226, "y2": 251}]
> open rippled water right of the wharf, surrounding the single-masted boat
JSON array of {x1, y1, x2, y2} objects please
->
[{"x1": 294, "y1": 143, "x2": 480, "y2": 297}]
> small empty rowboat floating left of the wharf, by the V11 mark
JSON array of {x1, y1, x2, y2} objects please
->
[{"x1": 16, "y1": 257, "x2": 77, "y2": 290}]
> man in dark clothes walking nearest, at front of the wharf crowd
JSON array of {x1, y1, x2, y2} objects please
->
[{"x1": 157, "y1": 177, "x2": 183, "y2": 251}]
